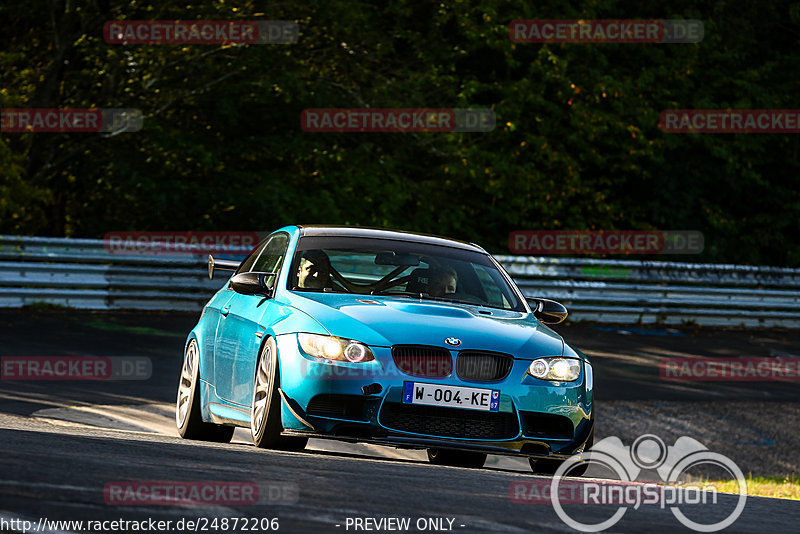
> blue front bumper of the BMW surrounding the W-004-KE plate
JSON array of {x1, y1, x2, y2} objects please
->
[{"x1": 276, "y1": 334, "x2": 594, "y2": 458}]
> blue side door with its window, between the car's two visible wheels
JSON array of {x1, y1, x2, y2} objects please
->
[{"x1": 215, "y1": 232, "x2": 289, "y2": 406}]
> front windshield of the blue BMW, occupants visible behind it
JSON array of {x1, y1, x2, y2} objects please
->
[{"x1": 288, "y1": 237, "x2": 525, "y2": 311}]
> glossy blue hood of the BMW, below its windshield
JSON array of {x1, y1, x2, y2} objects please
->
[{"x1": 289, "y1": 292, "x2": 564, "y2": 359}]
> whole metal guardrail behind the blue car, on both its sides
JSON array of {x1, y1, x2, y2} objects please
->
[{"x1": 0, "y1": 236, "x2": 800, "y2": 328}]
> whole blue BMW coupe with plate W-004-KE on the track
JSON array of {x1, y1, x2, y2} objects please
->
[{"x1": 176, "y1": 226, "x2": 594, "y2": 474}]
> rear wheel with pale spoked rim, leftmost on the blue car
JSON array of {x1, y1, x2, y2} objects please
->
[{"x1": 175, "y1": 339, "x2": 234, "y2": 443}]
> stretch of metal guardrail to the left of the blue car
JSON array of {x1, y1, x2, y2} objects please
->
[{"x1": 0, "y1": 236, "x2": 234, "y2": 311}]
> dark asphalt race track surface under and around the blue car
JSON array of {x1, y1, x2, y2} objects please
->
[{"x1": 0, "y1": 310, "x2": 800, "y2": 532}]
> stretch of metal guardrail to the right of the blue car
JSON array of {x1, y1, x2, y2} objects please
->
[{"x1": 496, "y1": 256, "x2": 800, "y2": 328}]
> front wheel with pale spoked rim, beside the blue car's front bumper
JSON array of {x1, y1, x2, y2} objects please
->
[{"x1": 250, "y1": 337, "x2": 308, "y2": 450}]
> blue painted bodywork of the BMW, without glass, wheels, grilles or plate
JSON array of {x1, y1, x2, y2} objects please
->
[{"x1": 187, "y1": 226, "x2": 594, "y2": 459}]
